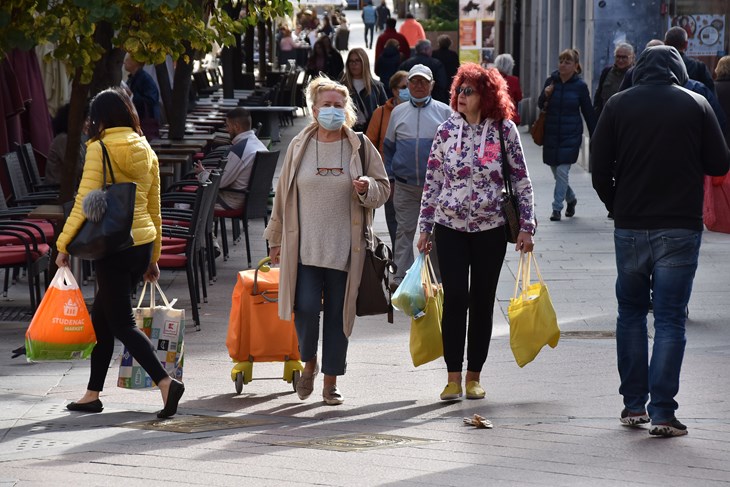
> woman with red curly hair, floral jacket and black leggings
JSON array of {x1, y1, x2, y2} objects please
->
[{"x1": 418, "y1": 63, "x2": 535, "y2": 400}]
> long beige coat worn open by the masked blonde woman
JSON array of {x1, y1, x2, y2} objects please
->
[{"x1": 264, "y1": 123, "x2": 390, "y2": 337}]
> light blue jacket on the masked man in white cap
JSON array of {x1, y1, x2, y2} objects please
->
[{"x1": 383, "y1": 99, "x2": 451, "y2": 186}]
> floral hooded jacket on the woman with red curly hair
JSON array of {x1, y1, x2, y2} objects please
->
[{"x1": 419, "y1": 112, "x2": 535, "y2": 233}]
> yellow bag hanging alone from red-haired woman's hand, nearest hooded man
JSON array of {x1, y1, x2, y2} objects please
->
[{"x1": 507, "y1": 252, "x2": 560, "y2": 367}]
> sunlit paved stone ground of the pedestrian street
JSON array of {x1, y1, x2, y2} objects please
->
[{"x1": 0, "y1": 15, "x2": 730, "y2": 487}]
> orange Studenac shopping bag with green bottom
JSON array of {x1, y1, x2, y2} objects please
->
[{"x1": 25, "y1": 267, "x2": 96, "y2": 362}]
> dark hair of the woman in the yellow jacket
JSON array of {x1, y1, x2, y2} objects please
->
[{"x1": 89, "y1": 86, "x2": 142, "y2": 139}]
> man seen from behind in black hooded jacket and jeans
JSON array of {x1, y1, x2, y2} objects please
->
[{"x1": 591, "y1": 46, "x2": 730, "y2": 436}]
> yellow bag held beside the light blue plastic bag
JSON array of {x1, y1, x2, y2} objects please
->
[{"x1": 410, "y1": 255, "x2": 444, "y2": 367}]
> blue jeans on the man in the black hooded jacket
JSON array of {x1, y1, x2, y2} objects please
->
[{"x1": 614, "y1": 228, "x2": 702, "y2": 424}]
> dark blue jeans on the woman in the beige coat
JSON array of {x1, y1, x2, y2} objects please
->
[{"x1": 294, "y1": 264, "x2": 348, "y2": 375}]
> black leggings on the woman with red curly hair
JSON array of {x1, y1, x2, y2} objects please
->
[{"x1": 434, "y1": 224, "x2": 507, "y2": 372}]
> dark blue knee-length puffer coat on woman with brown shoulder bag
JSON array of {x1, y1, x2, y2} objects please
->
[{"x1": 537, "y1": 71, "x2": 596, "y2": 166}]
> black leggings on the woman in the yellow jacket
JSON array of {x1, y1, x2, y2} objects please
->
[{"x1": 88, "y1": 243, "x2": 168, "y2": 391}]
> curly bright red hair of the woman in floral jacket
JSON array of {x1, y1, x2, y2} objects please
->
[{"x1": 451, "y1": 63, "x2": 515, "y2": 120}]
